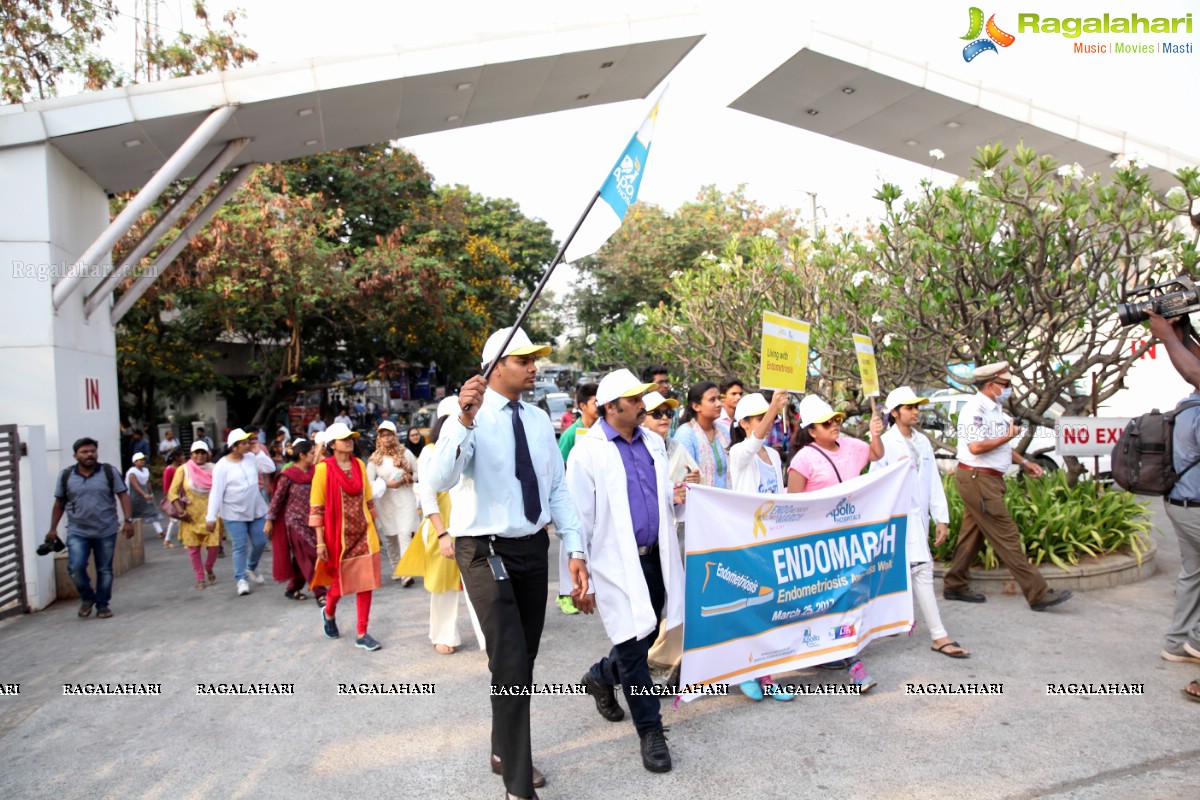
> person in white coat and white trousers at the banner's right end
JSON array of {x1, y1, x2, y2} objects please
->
[{"x1": 871, "y1": 386, "x2": 971, "y2": 658}]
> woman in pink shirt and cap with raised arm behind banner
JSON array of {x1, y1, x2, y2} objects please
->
[{"x1": 787, "y1": 395, "x2": 883, "y2": 694}]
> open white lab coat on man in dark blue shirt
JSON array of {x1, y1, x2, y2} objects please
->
[{"x1": 566, "y1": 425, "x2": 684, "y2": 644}]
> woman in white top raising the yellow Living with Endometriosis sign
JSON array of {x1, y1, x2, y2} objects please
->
[{"x1": 730, "y1": 391, "x2": 796, "y2": 702}]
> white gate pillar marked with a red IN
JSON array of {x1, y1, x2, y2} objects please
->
[{"x1": 0, "y1": 144, "x2": 120, "y2": 607}]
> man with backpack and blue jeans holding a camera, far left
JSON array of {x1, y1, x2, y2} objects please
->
[{"x1": 44, "y1": 438, "x2": 133, "y2": 619}]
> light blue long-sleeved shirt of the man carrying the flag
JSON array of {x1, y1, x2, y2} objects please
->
[{"x1": 421, "y1": 387, "x2": 583, "y2": 552}]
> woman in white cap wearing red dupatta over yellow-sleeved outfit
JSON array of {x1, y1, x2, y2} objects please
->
[{"x1": 308, "y1": 422, "x2": 383, "y2": 650}]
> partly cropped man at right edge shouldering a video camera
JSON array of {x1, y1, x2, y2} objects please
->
[{"x1": 1146, "y1": 311, "x2": 1200, "y2": 703}]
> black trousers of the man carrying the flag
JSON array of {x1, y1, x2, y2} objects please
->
[{"x1": 455, "y1": 530, "x2": 550, "y2": 798}]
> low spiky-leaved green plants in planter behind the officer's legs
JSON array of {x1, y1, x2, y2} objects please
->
[{"x1": 931, "y1": 470, "x2": 1151, "y2": 570}]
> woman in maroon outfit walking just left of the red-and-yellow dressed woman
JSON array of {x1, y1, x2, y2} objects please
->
[{"x1": 263, "y1": 439, "x2": 325, "y2": 604}]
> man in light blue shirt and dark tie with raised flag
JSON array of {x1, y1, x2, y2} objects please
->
[{"x1": 422, "y1": 89, "x2": 662, "y2": 798}]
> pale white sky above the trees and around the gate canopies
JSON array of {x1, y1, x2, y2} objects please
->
[{"x1": 98, "y1": 0, "x2": 1200, "y2": 287}]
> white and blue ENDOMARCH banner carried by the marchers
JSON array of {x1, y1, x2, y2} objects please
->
[{"x1": 680, "y1": 462, "x2": 913, "y2": 697}]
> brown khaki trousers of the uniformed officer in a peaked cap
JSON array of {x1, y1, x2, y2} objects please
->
[{"x1": 942, "y1": 468, "x2": 1050, "y2": 604}]
